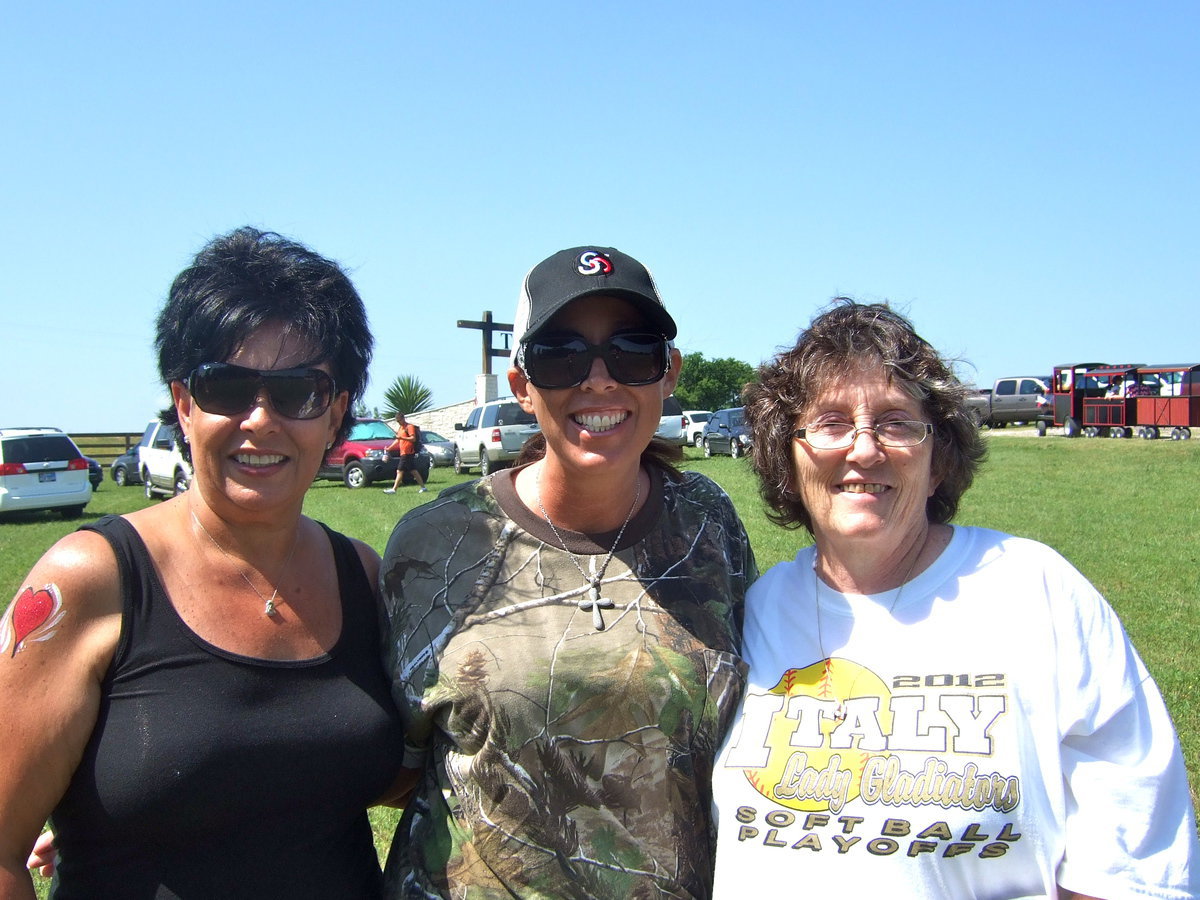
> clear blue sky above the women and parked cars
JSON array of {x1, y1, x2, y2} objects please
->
[{"x1": 0, "y1": 0, "x2": 1200, "y2": 431}]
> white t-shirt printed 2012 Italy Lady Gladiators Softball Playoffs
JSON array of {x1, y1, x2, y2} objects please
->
[{"x1": 714, "y1": 527, "x2": 1200, "y2": 900}]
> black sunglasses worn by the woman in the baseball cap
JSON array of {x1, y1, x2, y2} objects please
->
[{"x1": 523, "y1": 332, "x2": 671, "y2": 390}]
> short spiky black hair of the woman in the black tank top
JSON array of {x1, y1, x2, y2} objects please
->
[{"x1": 155, "y1": 226, "x2": 374, "y2": 440}]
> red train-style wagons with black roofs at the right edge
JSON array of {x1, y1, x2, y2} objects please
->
[{"x1": 1038, "y1": 362, "x2": 1200, "y2": 440}]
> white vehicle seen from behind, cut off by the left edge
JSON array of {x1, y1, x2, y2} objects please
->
[{"x1": 0, "y1": 428, "x2": 91, "y2": 518}]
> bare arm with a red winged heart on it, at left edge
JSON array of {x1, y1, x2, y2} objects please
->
[{"x1": 0, "y1": 532, "x2": 121, "y2": 872}]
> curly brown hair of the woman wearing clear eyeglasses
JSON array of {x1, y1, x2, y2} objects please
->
[{"x1": 744, "y1": 296, "x2": 986, "y2": 533}]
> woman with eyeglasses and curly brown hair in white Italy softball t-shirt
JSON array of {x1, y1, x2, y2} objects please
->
[{"x1": 714, "y1": 300, "x2": 1200, "y2": 900}]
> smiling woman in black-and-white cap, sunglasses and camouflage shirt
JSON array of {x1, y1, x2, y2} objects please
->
[{"x1": 380, "y1": 247, "x2": 756, "y2": 898}]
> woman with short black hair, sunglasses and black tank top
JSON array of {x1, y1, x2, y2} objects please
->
[{"x1": 0, "y1": 228, "x2": 402, "y2": 900}]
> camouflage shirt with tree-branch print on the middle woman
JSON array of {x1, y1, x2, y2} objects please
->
[{"x1": 380, "y1": 469, "x2": 756, "y2": 900}]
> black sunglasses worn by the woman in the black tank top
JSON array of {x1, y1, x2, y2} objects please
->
[{"x1": 187, "y1": 362, "x2": 336, "y2": 419}]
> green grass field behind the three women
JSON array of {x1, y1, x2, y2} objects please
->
[{"x1": 0, "y1": 428, "x2": 1200, "y2": 897}]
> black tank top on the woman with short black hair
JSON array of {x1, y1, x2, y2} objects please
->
[{"x1": 52, "y1": 516, "x2": 403, "y2": 900}]
